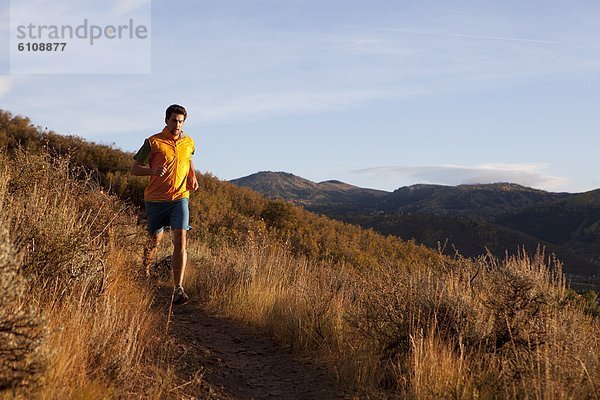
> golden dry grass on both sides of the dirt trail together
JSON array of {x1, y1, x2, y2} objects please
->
[{"x1": 0, "y1": 148, "x2": 600, "y2": 399}]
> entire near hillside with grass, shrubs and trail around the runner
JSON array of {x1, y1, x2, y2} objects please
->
[{"x1": 0, "y1": 108, "x2": 600, "y2": 399}]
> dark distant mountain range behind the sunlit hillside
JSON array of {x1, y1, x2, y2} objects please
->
[{"x1": 230, "y1": 171, "x2": 600, "y2": 282}]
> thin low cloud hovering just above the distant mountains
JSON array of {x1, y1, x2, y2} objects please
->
[{"x1": 352, "y1": 163, "x2": 569, "y2": 190}]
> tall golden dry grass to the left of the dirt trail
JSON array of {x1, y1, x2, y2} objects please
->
[{"x1": 0, "y1": 153, "x2": 204, "y2": 399}]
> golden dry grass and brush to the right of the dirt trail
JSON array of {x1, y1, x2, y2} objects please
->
[{"x1": 187, "y1": 234, "x2": 600, "y2": 399}]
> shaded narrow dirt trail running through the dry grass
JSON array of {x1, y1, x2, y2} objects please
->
[{"x1": 157, "y1": 288, "x2": 353, "y2": 400}]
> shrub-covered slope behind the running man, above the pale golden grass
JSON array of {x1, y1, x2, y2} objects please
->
[{"x1": 0, "y1": 112, "x2": 437, "y2": 268}]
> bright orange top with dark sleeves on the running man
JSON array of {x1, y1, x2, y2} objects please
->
[{"x1": 133, "y1": 127, "x2": 194, "y2": 201}]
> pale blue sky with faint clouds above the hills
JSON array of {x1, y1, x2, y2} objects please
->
[{"x1": 0, "y1": 0, "x2": 600, "y2": 192}]
